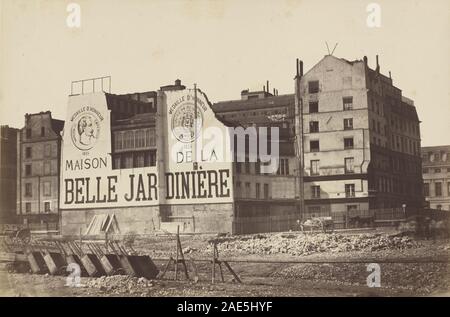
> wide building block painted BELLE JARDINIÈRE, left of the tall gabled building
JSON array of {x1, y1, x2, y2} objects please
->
[{"x1": 60, "y1": 80, "x2": 299, "y2": 235}]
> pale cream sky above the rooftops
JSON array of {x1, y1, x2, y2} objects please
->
[{"x1": 0, "y1": 0, "x2": 450, "y2": 146}]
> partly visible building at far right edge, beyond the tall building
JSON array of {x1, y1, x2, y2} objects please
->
[{"x1": 422, "y1": 145, "x2": 450, "y2": 210}]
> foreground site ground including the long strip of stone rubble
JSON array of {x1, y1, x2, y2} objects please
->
[{"x1": 0, "y1": 228, "x2": 450, "y2": 297}]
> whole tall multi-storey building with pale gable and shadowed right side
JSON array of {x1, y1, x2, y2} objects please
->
[{"x1": 300, "y1": 55, "x2": 423, "y2": 215}]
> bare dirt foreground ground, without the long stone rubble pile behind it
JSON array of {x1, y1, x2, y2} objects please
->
[{"x1": 0, "y1": 232, "x2": 450, "y2": 297}]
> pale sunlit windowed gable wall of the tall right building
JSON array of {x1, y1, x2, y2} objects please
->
[{"x1": 301, "y1": 56, "x2": 370, "y2": 213}]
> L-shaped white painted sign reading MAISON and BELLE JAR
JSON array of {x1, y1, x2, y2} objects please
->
[{"x1": 60, "y1": 93, "x2": 158, "y2": 209}]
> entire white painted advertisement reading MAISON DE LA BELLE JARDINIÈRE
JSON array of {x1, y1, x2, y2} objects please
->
[{"x1": 60, "y1": 89, "x2": 233, "y2": 209}]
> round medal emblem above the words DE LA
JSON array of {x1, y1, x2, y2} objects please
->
[{"x1": 172, "y1": 102, "x2": 203, "y2": 143}]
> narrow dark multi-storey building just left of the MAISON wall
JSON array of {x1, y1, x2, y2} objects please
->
[{"x1": 17, "y1": 111, "x2": 64, "y2": 229}]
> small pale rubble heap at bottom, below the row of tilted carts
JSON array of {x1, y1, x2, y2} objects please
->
[{"x1": 86, "y1": 275, "x2": 153, "y2": 295}]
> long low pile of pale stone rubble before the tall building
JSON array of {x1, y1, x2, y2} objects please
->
[{"x1": 206, "y1": 233, "x2": 420, "y2": 255}]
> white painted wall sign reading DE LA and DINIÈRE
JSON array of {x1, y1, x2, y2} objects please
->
[{"x1": 164, "y1": 89, "x2": 233, "y2": 204}]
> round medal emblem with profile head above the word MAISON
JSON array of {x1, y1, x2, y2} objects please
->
[{"x1": 70, "y1": 110, "x2": 100, "y2": 151}]
